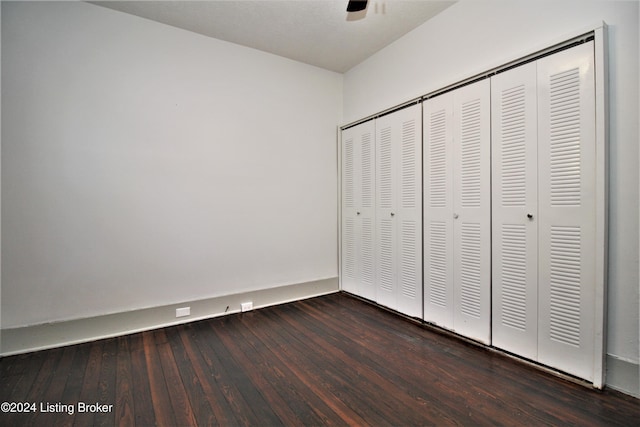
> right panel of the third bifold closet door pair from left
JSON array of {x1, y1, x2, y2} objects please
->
[{"x1": 453, "y1": 80, "x2": 491, "y2": 343}]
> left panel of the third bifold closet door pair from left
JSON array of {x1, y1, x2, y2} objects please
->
[{"x1": 423, "y1": 92, "x2": 453, "y2": 329}]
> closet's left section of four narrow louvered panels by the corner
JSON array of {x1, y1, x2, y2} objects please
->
[{"x1": 341, "y1": 104, "x2": 422, "y2": 318}]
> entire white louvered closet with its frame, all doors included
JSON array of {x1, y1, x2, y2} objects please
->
[{"x1": 341, "y1": 33, "x2": 607, "y2": 387}]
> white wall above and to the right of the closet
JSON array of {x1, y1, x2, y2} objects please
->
[{"x1": 344, "y1": 0, "x2": 639, "y2": 392}]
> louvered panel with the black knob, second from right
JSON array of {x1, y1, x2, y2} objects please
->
[{"x1": 491, "y1": 63, "x2": 538, "y2": 360}]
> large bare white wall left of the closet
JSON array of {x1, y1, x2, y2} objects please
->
[{"x1": 2, "y1": 2, "x2": 342, "y2": 328}]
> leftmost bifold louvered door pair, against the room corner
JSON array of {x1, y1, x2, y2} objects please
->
[{"x1": 341, "y1": 121, "x2": 376, "y2": 300}]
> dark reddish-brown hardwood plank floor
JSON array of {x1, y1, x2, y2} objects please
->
[{"x1": 0, "y1": 294, "x2": 640, "y2": 426}]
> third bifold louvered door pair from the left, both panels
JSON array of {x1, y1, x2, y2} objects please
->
[{"x1": 424, "y1": 80, "x2": 491, "y2": 344}]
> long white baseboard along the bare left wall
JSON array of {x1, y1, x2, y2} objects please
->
[{"x1": 0, "y1": 277, "x2": 339, "y2": 356}]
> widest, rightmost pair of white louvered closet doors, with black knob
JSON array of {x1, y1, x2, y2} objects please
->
[{"x1": 491, "y1": 42, "x2": 602, "y2": 380}]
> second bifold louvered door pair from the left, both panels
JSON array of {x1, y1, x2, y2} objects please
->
[{"x1": 375, "y1": 105, "x2": 422, "y2": 317}]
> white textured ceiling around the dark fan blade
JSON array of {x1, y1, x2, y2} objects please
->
[{"x1": 91, "y1": 0, "x2": 455, "y2": 73}]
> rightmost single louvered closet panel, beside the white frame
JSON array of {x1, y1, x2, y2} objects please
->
[{"x1": 538, "y1": 42, "x2": 596, "y2": 380}]
